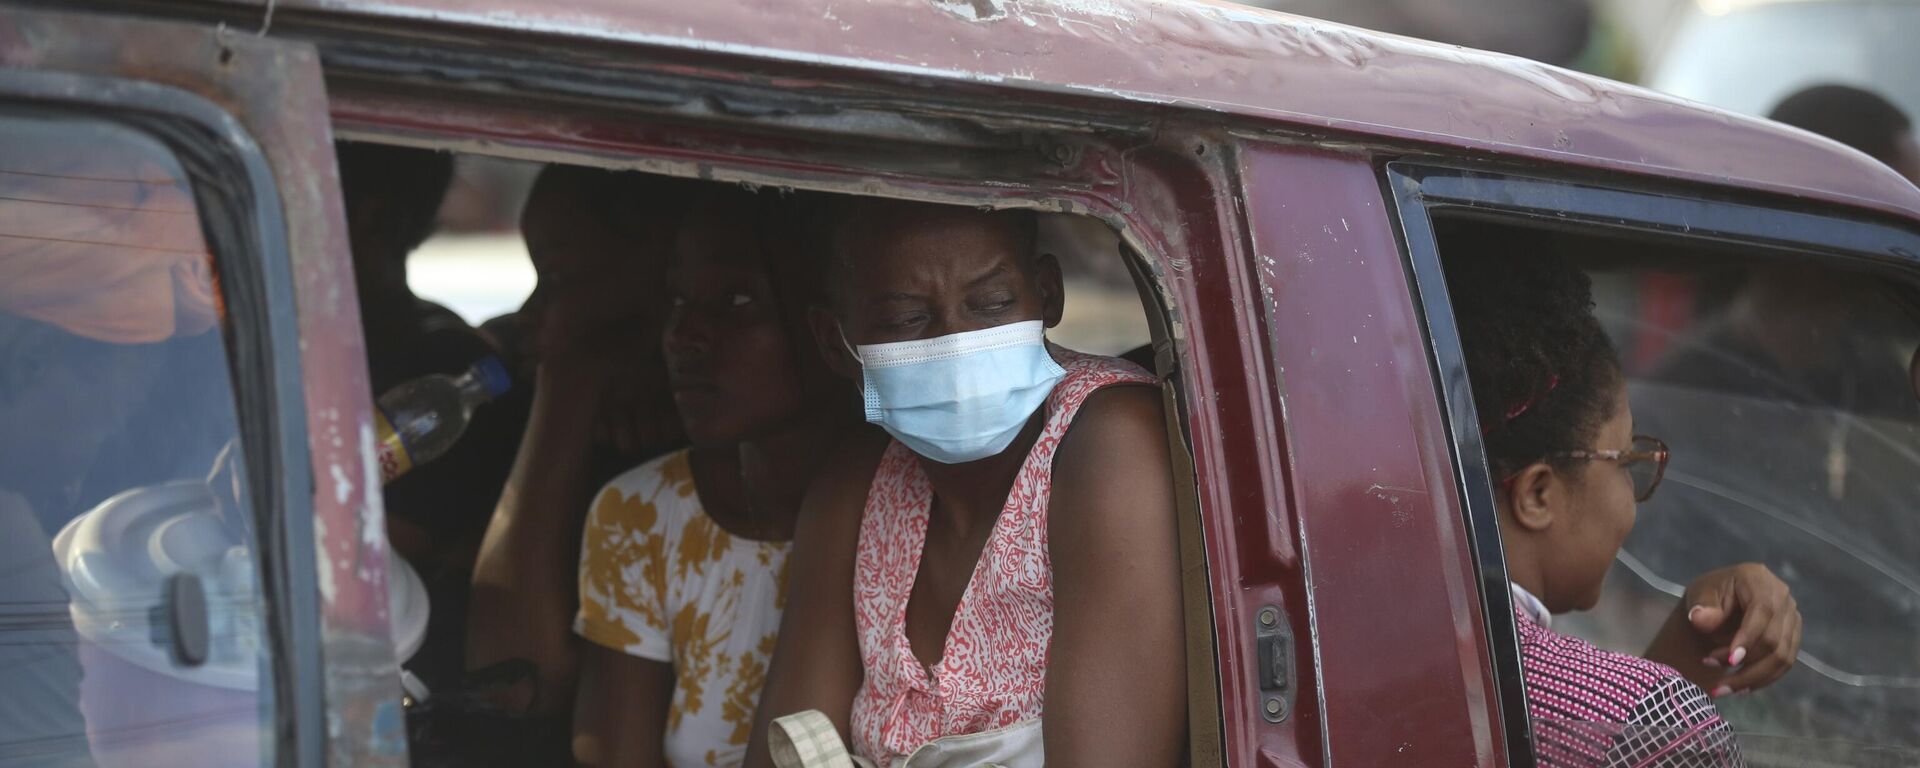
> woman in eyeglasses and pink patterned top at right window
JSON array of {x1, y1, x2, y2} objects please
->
[{"x1": 1448, "y1": 244, "x2": 1801, "y2": 766}]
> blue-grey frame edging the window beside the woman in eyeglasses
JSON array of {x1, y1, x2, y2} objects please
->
[{"x1": 1384, "y1": 159, "x2": 1920, "y2": 768}]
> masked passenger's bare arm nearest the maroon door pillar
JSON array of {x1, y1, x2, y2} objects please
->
[{"x1": 1041, "y1": 386, "x2": 1187, "y2": 768}]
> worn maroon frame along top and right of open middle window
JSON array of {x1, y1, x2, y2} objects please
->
[{"x1": 319, "y1": 81, "x2": 1228, "y2": 764}]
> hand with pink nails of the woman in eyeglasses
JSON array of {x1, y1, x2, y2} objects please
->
[{"x1": 1642, "y1": 563, "x2": 1801, "y2": 697}]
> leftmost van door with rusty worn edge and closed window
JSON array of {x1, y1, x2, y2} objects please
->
[{"x1": 0, "y1": 10, "x2": 385, "y2": 766}]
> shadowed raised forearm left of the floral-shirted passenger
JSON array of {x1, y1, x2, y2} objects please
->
[{"x1": 467, "y1": 365, "x2": 597, "y2": 712}]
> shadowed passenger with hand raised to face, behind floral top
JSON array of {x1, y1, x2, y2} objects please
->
[{"x1": 467, "y1": 165, "x2": 695, "y2": 721}]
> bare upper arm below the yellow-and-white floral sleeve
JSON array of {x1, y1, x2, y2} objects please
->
[{"x1": 574, "y1": 643, "x2": 674, "y2": 768}]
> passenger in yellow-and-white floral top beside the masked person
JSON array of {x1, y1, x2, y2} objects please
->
[{"x1": 574, "y1": 188, "x2": 858, "y2": 766}]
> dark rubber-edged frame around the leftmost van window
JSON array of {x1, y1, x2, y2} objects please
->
[{"x1": 0, "y1": 69, "x2": 326, "y2": 768}]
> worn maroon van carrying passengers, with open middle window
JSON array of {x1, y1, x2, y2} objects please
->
[{"x1": 0, "y1": 0, "x2": 1920, "y2": 766}]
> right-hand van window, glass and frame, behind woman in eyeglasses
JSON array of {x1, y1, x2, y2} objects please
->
[{"x1": 1386, "y1": 159, "x2": 1920, "y2": 766}]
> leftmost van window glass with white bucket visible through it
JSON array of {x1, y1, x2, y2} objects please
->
[{"x1": 0, "y1": 111, "x2": 273, "y2": 766}]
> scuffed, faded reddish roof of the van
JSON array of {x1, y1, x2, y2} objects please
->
[{"x1": 232, "y1": 0, "x2": 1920, "y2": 219}]
